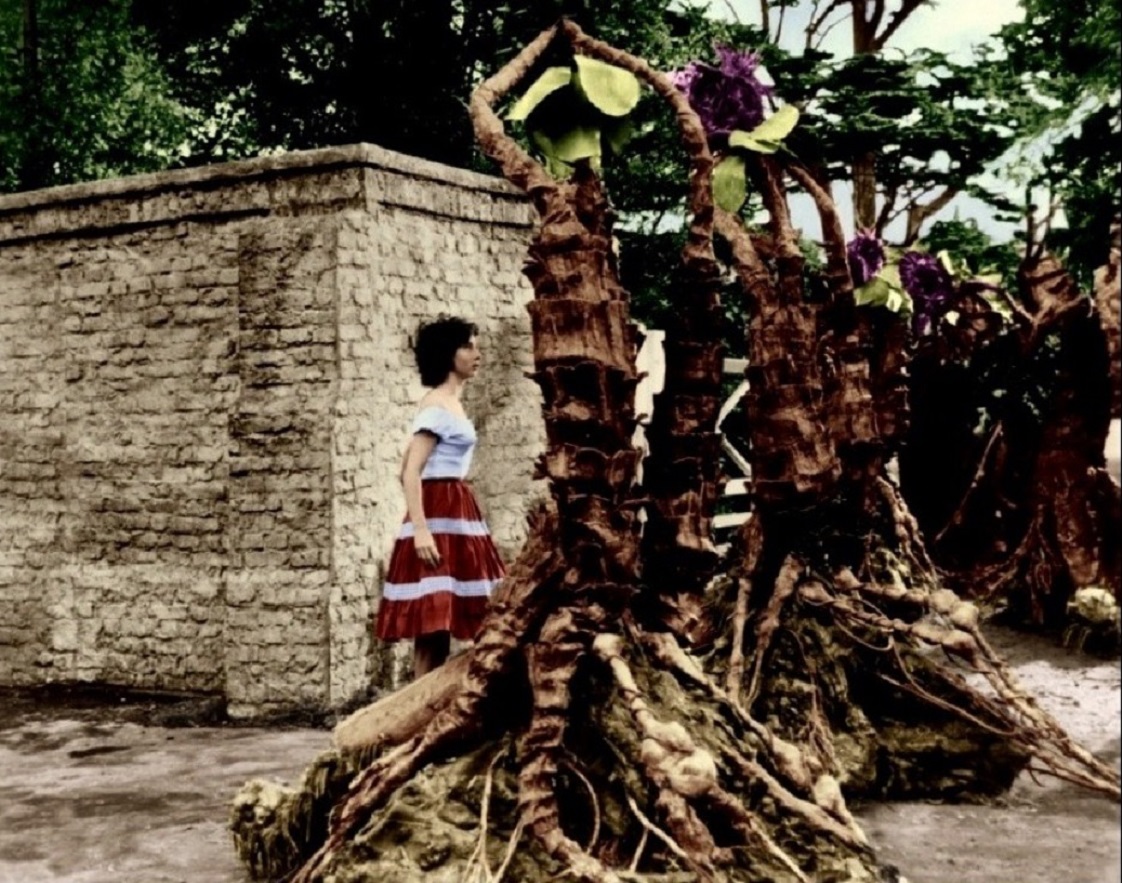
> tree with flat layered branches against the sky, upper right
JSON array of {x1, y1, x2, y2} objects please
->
[{"x1": 761, "y1": 0, "x2": 1011, "y2": 245}]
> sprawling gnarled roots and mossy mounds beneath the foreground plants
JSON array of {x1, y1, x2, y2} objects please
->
[{"x1": 231, "y1": 500, "x2": 1120, "y2": 883}]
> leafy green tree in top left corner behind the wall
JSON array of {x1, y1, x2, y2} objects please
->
[{"x1": 0, "y1": 0, "x2": 186, "y2": 191}]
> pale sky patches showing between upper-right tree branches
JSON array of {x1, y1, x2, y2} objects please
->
[{"x1": 695, "y1": 0, "x2": 1023, "y2": 239}]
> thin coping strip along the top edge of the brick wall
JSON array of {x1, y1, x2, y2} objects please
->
[{"x1": 0, "y1": 144, "x2": 524, "y2": 217}]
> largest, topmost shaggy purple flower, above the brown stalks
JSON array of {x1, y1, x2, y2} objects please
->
[{"x1": 671, "y1": 46, "x2": 774, "y2": 137}]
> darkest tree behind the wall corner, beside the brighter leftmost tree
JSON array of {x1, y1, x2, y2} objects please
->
[{"x1": 135, "y1": 0, "x2": 753, "y2": 167}]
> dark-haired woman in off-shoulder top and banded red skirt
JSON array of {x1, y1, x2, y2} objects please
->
[{"x1": 377, "y1": 319, "x2": 505, "y2": 678}]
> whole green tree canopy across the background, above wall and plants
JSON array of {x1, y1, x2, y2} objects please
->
[{"x1": 0, "y1": 0, "x2": 1122, "y2": 282}]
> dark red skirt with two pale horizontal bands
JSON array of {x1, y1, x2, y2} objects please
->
[{"x1": 376, "y1": 478, "x2": 506, "y2": 641}]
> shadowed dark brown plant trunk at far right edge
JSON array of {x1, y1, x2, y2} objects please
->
[{"x1": 901, "y1": 256, "x2": 1122, "y2": 628}]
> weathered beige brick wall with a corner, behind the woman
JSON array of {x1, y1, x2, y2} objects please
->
[{"x1": 0, "y1": 145, "x2": 542, "y2": 716}]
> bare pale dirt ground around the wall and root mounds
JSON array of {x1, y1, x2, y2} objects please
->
[{"x1": 0, "y1": 629, "x2": 1122, "y2": 883}]
